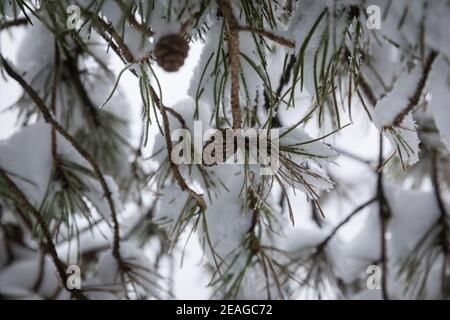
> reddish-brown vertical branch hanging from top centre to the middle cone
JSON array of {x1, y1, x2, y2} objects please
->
[{"x1": 218, "y1": 0, "x2": 241, "y2": 130}]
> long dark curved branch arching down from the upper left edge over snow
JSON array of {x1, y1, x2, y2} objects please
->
[{"x1": 1, "y1": 57, "x2": 126, "y2": 270}]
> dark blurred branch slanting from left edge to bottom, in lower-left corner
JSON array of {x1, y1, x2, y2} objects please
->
[{"x1": 0, "y1": 168, "x2": 87, "y2": 300}]
